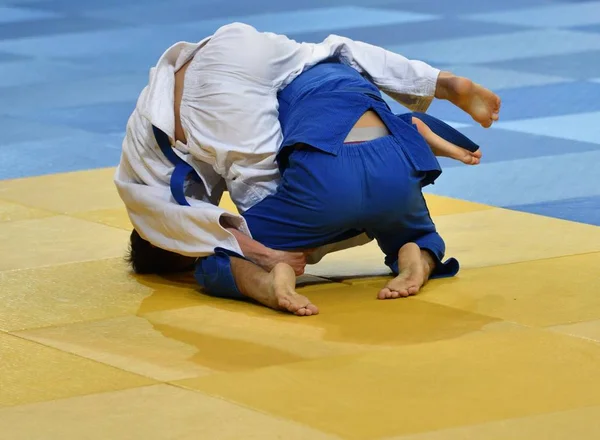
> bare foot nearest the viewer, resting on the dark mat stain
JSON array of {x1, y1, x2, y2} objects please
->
[{"x1": 254, "y1": 263, "x2": 319, "y2": 316}]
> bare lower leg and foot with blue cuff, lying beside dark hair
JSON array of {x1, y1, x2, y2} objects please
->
[{"x1": 194, "y1": 250, "x2": 319, "y2": 316}]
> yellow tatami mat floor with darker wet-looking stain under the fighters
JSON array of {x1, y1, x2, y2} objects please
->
[{"x1": 0, "y1": 169, "x2": 600, "y2": 440}]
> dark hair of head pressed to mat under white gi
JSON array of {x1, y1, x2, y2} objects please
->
[{"x1": 125, "y1": 229, "x2": 196, "y2": 274}]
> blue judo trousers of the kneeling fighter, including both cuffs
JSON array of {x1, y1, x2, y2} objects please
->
[{"x1": 196, "y1": 115, "x2": 459, "y2": 298}]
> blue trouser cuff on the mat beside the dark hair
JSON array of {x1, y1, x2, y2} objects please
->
[{"x1": 194, "y1": 248, "x2": 245, "y2": 299}]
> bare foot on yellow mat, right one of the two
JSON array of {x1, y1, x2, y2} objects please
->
[{"x1": 377, "y1": 243, "x2": 435, "y2": 299}]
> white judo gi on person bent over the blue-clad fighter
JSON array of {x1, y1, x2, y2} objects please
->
[{"x1": 114, "y1": 23, "x2": 439, "y2": 263}]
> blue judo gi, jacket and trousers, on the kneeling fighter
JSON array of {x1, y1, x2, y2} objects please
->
[{"x1": 157, "y1": 60, "x2": 478, "y2": 298}]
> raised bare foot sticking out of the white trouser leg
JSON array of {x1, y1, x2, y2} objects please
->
[{"x1": 436, "y1": 72, "x2": 502, "y2": 128}]
